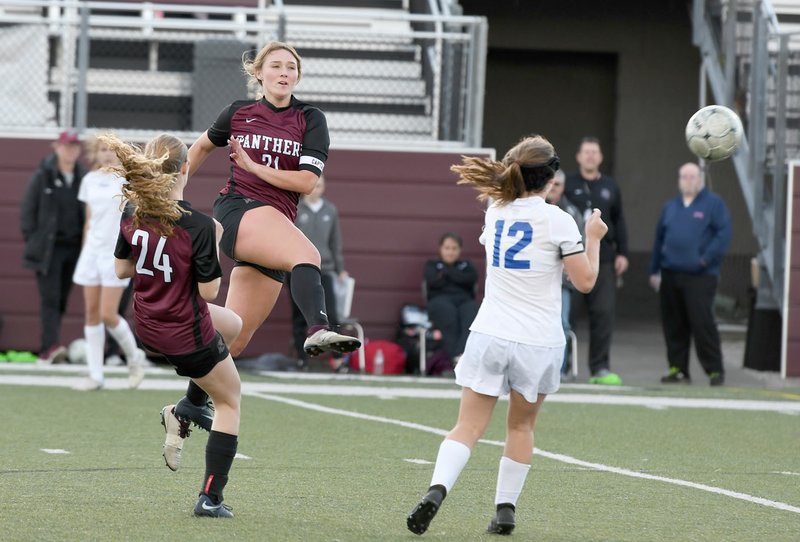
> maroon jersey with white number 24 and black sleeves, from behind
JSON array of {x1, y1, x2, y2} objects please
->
[{"x1": 114, "y1": 201, "x2": 222, "y2": 355}]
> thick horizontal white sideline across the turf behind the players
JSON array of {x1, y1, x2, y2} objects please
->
[{"x1": 0, "y1": 376, "x2": 800, "y2": 414}]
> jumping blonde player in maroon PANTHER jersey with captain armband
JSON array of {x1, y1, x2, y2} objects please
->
[{"x1": 189, "y1": 42, "x2": 360, "y2": 362}]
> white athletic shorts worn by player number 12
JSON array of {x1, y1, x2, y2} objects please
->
[{"x1": 456, "y1": 331, "x2": 564, "y2": 403}]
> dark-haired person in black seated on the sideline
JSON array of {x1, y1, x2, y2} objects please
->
[{"x1": 425, "y1": 232, "x2": 478, "y2": 364}]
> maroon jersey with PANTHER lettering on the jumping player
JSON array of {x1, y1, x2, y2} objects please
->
[{"x1": 208, "y1": 96, "x2": 330, "y2": 222}]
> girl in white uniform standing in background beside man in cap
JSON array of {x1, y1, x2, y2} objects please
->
[{"x1": 72, "y1": 136, "x2": 145, "y2": 391}]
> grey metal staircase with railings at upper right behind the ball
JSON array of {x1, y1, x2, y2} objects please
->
[{"x1": 693, "y1": 0, "x2": 800, "y2": 308}]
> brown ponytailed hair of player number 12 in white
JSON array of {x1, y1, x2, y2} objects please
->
[{"x1": 450, "y1": 135, "x2": 558, "y2": 205}]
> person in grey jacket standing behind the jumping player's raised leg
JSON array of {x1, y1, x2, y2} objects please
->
[{"x1": 286, "y1": 175, "x2": 350, "y2": 367}]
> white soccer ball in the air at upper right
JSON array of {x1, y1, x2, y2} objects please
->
[{"x1": 686, "y1": 105, "x2": 744, "y2": 162}]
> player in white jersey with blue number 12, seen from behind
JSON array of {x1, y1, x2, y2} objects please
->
[{"x1": 406, "y1": 136, "x2": 608, "y2": 534}]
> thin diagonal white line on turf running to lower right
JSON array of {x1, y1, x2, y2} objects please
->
[{"x1": 250, "y1": 393, "x2": 800, "y2": 514}]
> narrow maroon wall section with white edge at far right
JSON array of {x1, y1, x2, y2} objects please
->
[{"x1": 784, "y1": 164, "x2": 800, "y2": 376}]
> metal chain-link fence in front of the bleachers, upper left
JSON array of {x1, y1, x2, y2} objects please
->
[{"x1": 0, "y1": 0, "x2": 487, "y2": 147}]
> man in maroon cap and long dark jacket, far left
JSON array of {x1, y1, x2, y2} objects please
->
[{"x1": 20, "y1": 130, "x2": 86, "y2": 363}]
